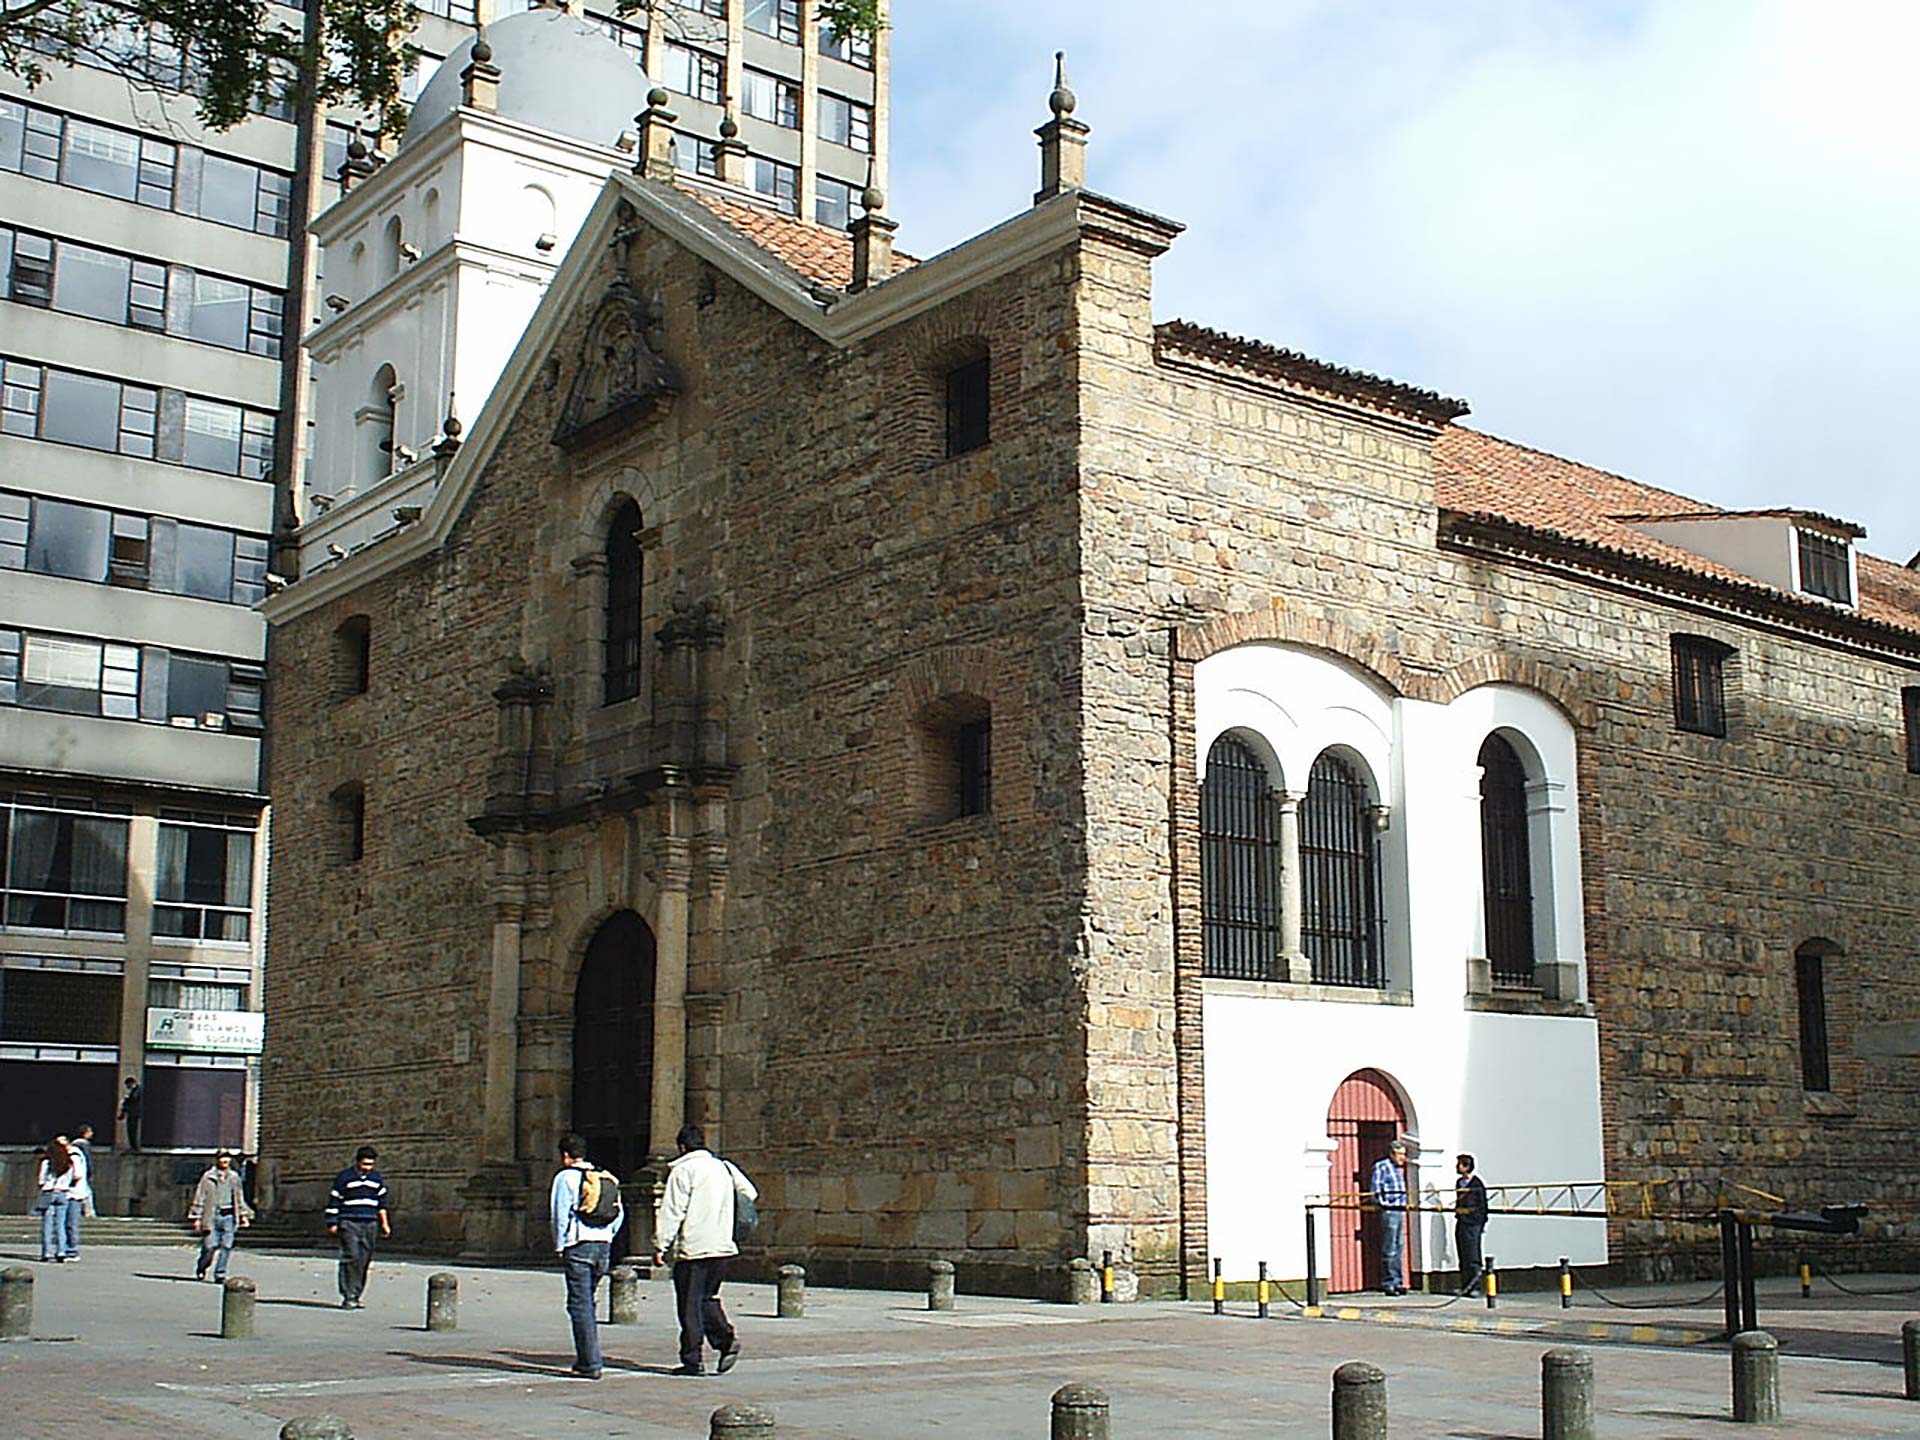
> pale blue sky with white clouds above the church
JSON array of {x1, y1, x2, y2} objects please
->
[{"x1": 887, "y1": 0, "x2": 1920, "y2": 563}]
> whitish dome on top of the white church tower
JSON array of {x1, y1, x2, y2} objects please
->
[{"x1": 399, "y1": 10, "x2": 653, "y2": 148}]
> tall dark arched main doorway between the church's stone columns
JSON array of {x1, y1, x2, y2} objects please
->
[{"x1": 572, "y1": 910, "x2": 653, "y2": 1205}]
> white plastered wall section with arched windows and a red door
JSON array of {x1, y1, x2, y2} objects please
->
[{"x1": 1192, "y1": 645, "x2": 1607, "y2": 1279}]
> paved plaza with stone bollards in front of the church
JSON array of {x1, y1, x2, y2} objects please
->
[{"x1": 0, "y1": 1244, "x2": 1920, "y2": 1440}]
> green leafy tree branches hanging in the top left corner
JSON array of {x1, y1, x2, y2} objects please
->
[{"x1": 0, "y1": 0, "x2": 417, "y2": 131}]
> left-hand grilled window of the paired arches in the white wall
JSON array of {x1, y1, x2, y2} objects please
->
[{"x1": 1200, "y1": 735, "x2": 1286, "y2": 979}]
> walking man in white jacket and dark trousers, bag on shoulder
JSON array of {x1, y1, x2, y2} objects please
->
[{"x1": 653, "y1": 1125, "x2": 760, "y2": 1375}]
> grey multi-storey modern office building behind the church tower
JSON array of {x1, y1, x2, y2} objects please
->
[{"x1": 0, "y1": 0, "x2": 885, "y2": 1148}]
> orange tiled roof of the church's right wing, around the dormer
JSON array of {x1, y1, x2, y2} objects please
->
[{"x1": 1434, "y1": 424, "x2": 1920, "y2": 634}]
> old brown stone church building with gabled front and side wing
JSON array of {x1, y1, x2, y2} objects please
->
[{"x1": 263, "y1": 53, "x2": 1920, "y2": 1294}]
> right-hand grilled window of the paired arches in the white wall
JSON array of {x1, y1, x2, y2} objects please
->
[{"x1": 1300, "y1": 753, "x2": 1386, "y2": 987}]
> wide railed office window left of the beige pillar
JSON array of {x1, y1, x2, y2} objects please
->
[{"x1": 0, "y1": 791, "x2": 129, "y2": 935}]
